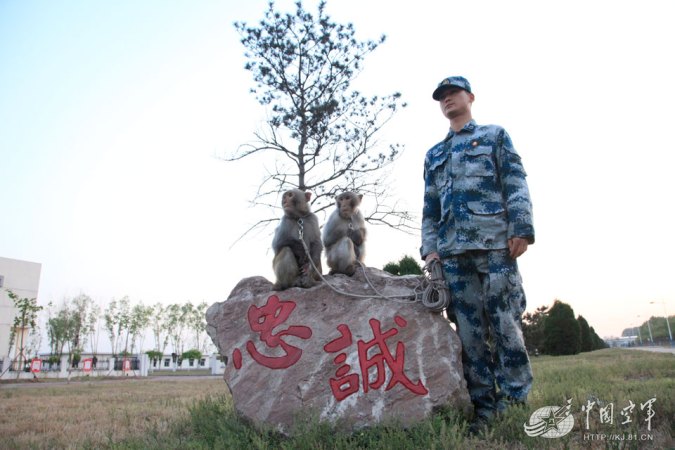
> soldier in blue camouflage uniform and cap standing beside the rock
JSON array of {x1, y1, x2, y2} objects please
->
[{"x1": 420, "y1": 76, "x2": 534, "y2": 433}]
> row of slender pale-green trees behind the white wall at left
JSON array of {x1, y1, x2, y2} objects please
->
[{"x1": 9, "y1": 294, "x2": 211, "y2": 362}]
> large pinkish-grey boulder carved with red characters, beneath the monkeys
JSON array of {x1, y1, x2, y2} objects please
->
[{"x1": 206, "y1": 268, "x2": 470, "y2": 433}]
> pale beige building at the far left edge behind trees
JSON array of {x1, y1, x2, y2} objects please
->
[{"x1": 0, "y1": 257, "x2": 42, "y2": 366}]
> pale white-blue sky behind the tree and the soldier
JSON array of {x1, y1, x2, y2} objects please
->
[{"x1": 0, "y1": 0, "x2": 675, "y2": 337}]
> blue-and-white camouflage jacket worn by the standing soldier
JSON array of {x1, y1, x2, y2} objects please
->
[{"x1": 420, "y1": 120, "x2": 534, "y2": 257}]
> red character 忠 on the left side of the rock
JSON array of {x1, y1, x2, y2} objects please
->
[{"x1": 242, "y1": 295, "x2": 312, "y2": 369}]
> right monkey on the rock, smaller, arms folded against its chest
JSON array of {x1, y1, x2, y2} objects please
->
[{"x1": 323, "y1": 192, "x2": 366, "y2": 276}]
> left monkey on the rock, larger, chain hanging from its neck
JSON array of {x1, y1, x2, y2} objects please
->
[{"x1": 272, "y1": 189, "x2": 323, "y2": 291}]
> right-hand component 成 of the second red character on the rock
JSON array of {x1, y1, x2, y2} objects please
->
[{"x1": 357, "y1": 316, "x2": 429, "y2": 395}]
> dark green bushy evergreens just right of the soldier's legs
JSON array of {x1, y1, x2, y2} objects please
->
[{"x1": 522, "y1": 300, "x2": 607, "y2": 355}]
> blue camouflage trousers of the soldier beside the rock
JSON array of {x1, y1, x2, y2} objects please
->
[{"x1": 443, "y1": 249, "x2": 532, "y2": 417}]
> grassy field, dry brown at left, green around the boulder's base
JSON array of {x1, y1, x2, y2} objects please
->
[{"x1": 0, "y1": 349, "x2": 675, "y2": 450}]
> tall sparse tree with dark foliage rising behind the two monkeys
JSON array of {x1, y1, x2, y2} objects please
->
[{"x1": 230, "y1": 2, "x2": 413, "y2": 234}]
